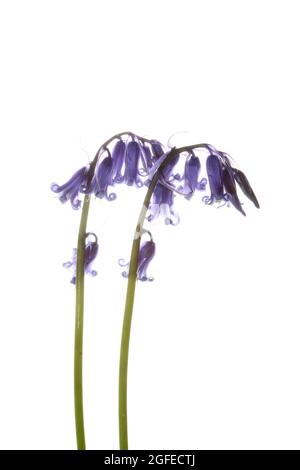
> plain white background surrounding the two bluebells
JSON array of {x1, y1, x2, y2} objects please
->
[{"x1": 0, "y1": 0, "x2": 300, "y2": 449}]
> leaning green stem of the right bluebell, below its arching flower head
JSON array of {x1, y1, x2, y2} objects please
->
[{"x1": 119, "y1": 173, "x2": 158, "y2": 450}]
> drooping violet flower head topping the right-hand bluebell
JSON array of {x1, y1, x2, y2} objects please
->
[{"x1": 147, "y1": 144, "x2": 259, "y2": 225}]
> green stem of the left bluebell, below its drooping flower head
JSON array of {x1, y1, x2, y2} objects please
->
[{"x1": 74, "y1": 196, "x2": 90, "y2": 450}]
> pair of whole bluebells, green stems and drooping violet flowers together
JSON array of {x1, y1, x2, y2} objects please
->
[{"x1": 51, "y1": 132, "x2": 259, "y2": 450}]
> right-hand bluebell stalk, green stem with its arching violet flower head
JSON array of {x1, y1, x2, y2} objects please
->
[{"x1": 119, "y1": 144, "x2": 259, "y2": 450}]
